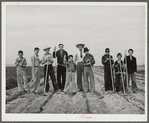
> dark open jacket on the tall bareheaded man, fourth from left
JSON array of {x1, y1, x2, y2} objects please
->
[{"x1": 53, "y1": 50, "x2": 68, "y2": 65}]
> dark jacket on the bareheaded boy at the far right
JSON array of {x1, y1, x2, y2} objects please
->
[{"x1": 124, "y1": 56, "x2": 137, "y2": 73}]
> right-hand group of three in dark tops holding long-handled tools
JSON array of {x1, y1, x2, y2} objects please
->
[{"x1": 102, "y1": 48, "x2": 138, "y2": 93}]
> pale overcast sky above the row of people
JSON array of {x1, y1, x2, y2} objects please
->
[{"x1": 6, "y1": 5, "x2": 145, "y2": 65}]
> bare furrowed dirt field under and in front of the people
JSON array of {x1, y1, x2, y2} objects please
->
[{"x1": 6, "y1": 67, "x2": 145, "y2": 114}]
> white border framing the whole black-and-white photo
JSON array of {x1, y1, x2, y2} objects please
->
[{"x1": 1, "y1": 2, "x2": 148, "y2": 122}]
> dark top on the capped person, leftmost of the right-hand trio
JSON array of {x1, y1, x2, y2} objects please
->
[{"x1": 102, "y1": 54, "x2": 114, "y2": 70}]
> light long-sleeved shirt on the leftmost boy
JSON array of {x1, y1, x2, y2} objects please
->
[{"x1": 15, "y1": 57, "x2": 27, "y2": 72}]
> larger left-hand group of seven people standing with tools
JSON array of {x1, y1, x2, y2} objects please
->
[{"x1": 15, "y1": 44, "x2": 102, "y2": 96}]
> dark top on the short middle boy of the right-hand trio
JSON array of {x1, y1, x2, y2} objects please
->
[{"x1": 114, "y1": 60, "x2": 124, "y2": 74}]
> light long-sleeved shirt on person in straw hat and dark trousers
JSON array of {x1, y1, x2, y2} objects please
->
[{"x1": 42, "y1": 53, "x2": 53, "y2": 65}]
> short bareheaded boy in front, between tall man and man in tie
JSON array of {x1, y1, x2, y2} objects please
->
[{"x1": 64, "y1": 55, "x2": 77, "y2": 95}]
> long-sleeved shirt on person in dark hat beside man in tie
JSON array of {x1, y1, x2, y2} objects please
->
[{"x1": 83, "y1": 54, "x2": 95, "y2": 66}]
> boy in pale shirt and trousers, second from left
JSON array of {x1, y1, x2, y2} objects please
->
[{"x1": 30, "y1": 47, "x2": 41, "y2": 94}]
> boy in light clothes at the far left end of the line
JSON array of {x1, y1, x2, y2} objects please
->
[{"x1": 15, "y1": 50, "x2": 29, "y2": 93}]
